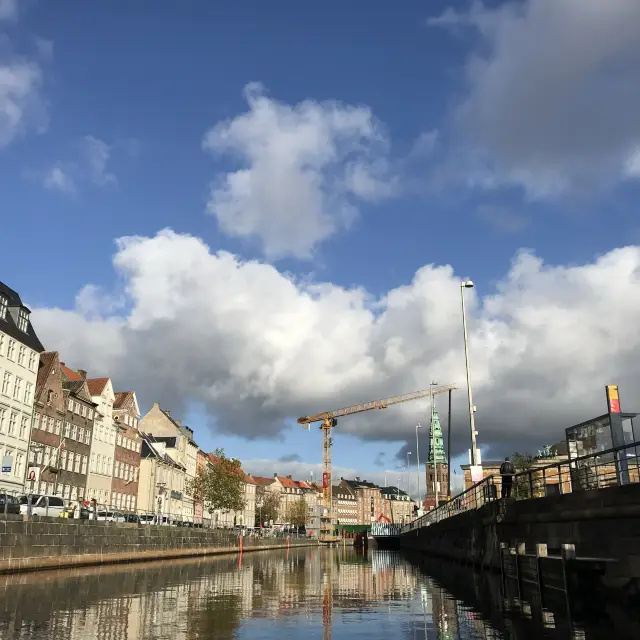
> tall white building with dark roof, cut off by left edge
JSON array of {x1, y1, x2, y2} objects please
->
[{"x1": 0, "y1": 282, "x2": 44, "y2": 492}]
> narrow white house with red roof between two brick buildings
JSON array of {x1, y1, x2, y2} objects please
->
[{"x1": 86, "y1": 378, "x2": 117, "y2": 505}]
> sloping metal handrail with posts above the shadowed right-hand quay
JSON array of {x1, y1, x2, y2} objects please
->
[{"x1": 402, "y1": 442, "x2": 640, "y2": 533}]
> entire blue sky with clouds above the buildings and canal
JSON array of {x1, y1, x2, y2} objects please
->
[{"x1": 0, "y1": 0, "x2": 640, "y2": 490}]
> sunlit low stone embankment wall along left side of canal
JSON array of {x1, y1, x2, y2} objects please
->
[{"x1": 0, "y1": 516, "x2": 318, "y2": 574}]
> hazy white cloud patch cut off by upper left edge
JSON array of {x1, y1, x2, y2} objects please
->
[{"x1": 0, "y1": 57, "x2": 47, "y2": 148}]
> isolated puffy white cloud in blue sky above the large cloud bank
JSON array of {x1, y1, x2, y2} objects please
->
[{"x1": 203, "y1": 84, "x2": 394, "y2": 259}]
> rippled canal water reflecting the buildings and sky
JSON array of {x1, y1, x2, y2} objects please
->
[{"x1": 0, "y1": 547, "x2": 640, "y2": 640}]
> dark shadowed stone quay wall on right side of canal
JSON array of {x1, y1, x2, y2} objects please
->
[{"x1": 400, "y1": 484, "x2": 640, "y2": 586}]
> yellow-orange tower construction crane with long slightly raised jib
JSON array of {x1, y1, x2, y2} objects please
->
[{"x1": 298, "y1": 385, "x2": 456, "y2": 540}]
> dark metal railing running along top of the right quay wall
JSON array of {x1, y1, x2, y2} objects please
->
[{"x1": 402, "y1": 442, "x2": 640, "y2": 533}]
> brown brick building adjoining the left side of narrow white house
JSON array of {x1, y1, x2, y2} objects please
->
[{"x1": 55, "y1": 362, "x2": 97, "y2": 500}]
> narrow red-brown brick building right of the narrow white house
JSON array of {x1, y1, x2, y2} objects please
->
[{"x1": 111, "y1": 391, "x2": 142, "y2": 511}]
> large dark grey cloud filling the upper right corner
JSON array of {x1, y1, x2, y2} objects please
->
[{"x1": 429, "y1": 0, "x2": 640, "y2": 198}]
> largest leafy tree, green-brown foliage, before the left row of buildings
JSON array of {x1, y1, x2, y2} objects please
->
[{"x1": 187, "y1": 449, "x2": 245, "y2": 511}]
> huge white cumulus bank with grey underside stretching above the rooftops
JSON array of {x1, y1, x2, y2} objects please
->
[{"x1": 33, "y1": 231, "x2": 640, "y2": 455}]
